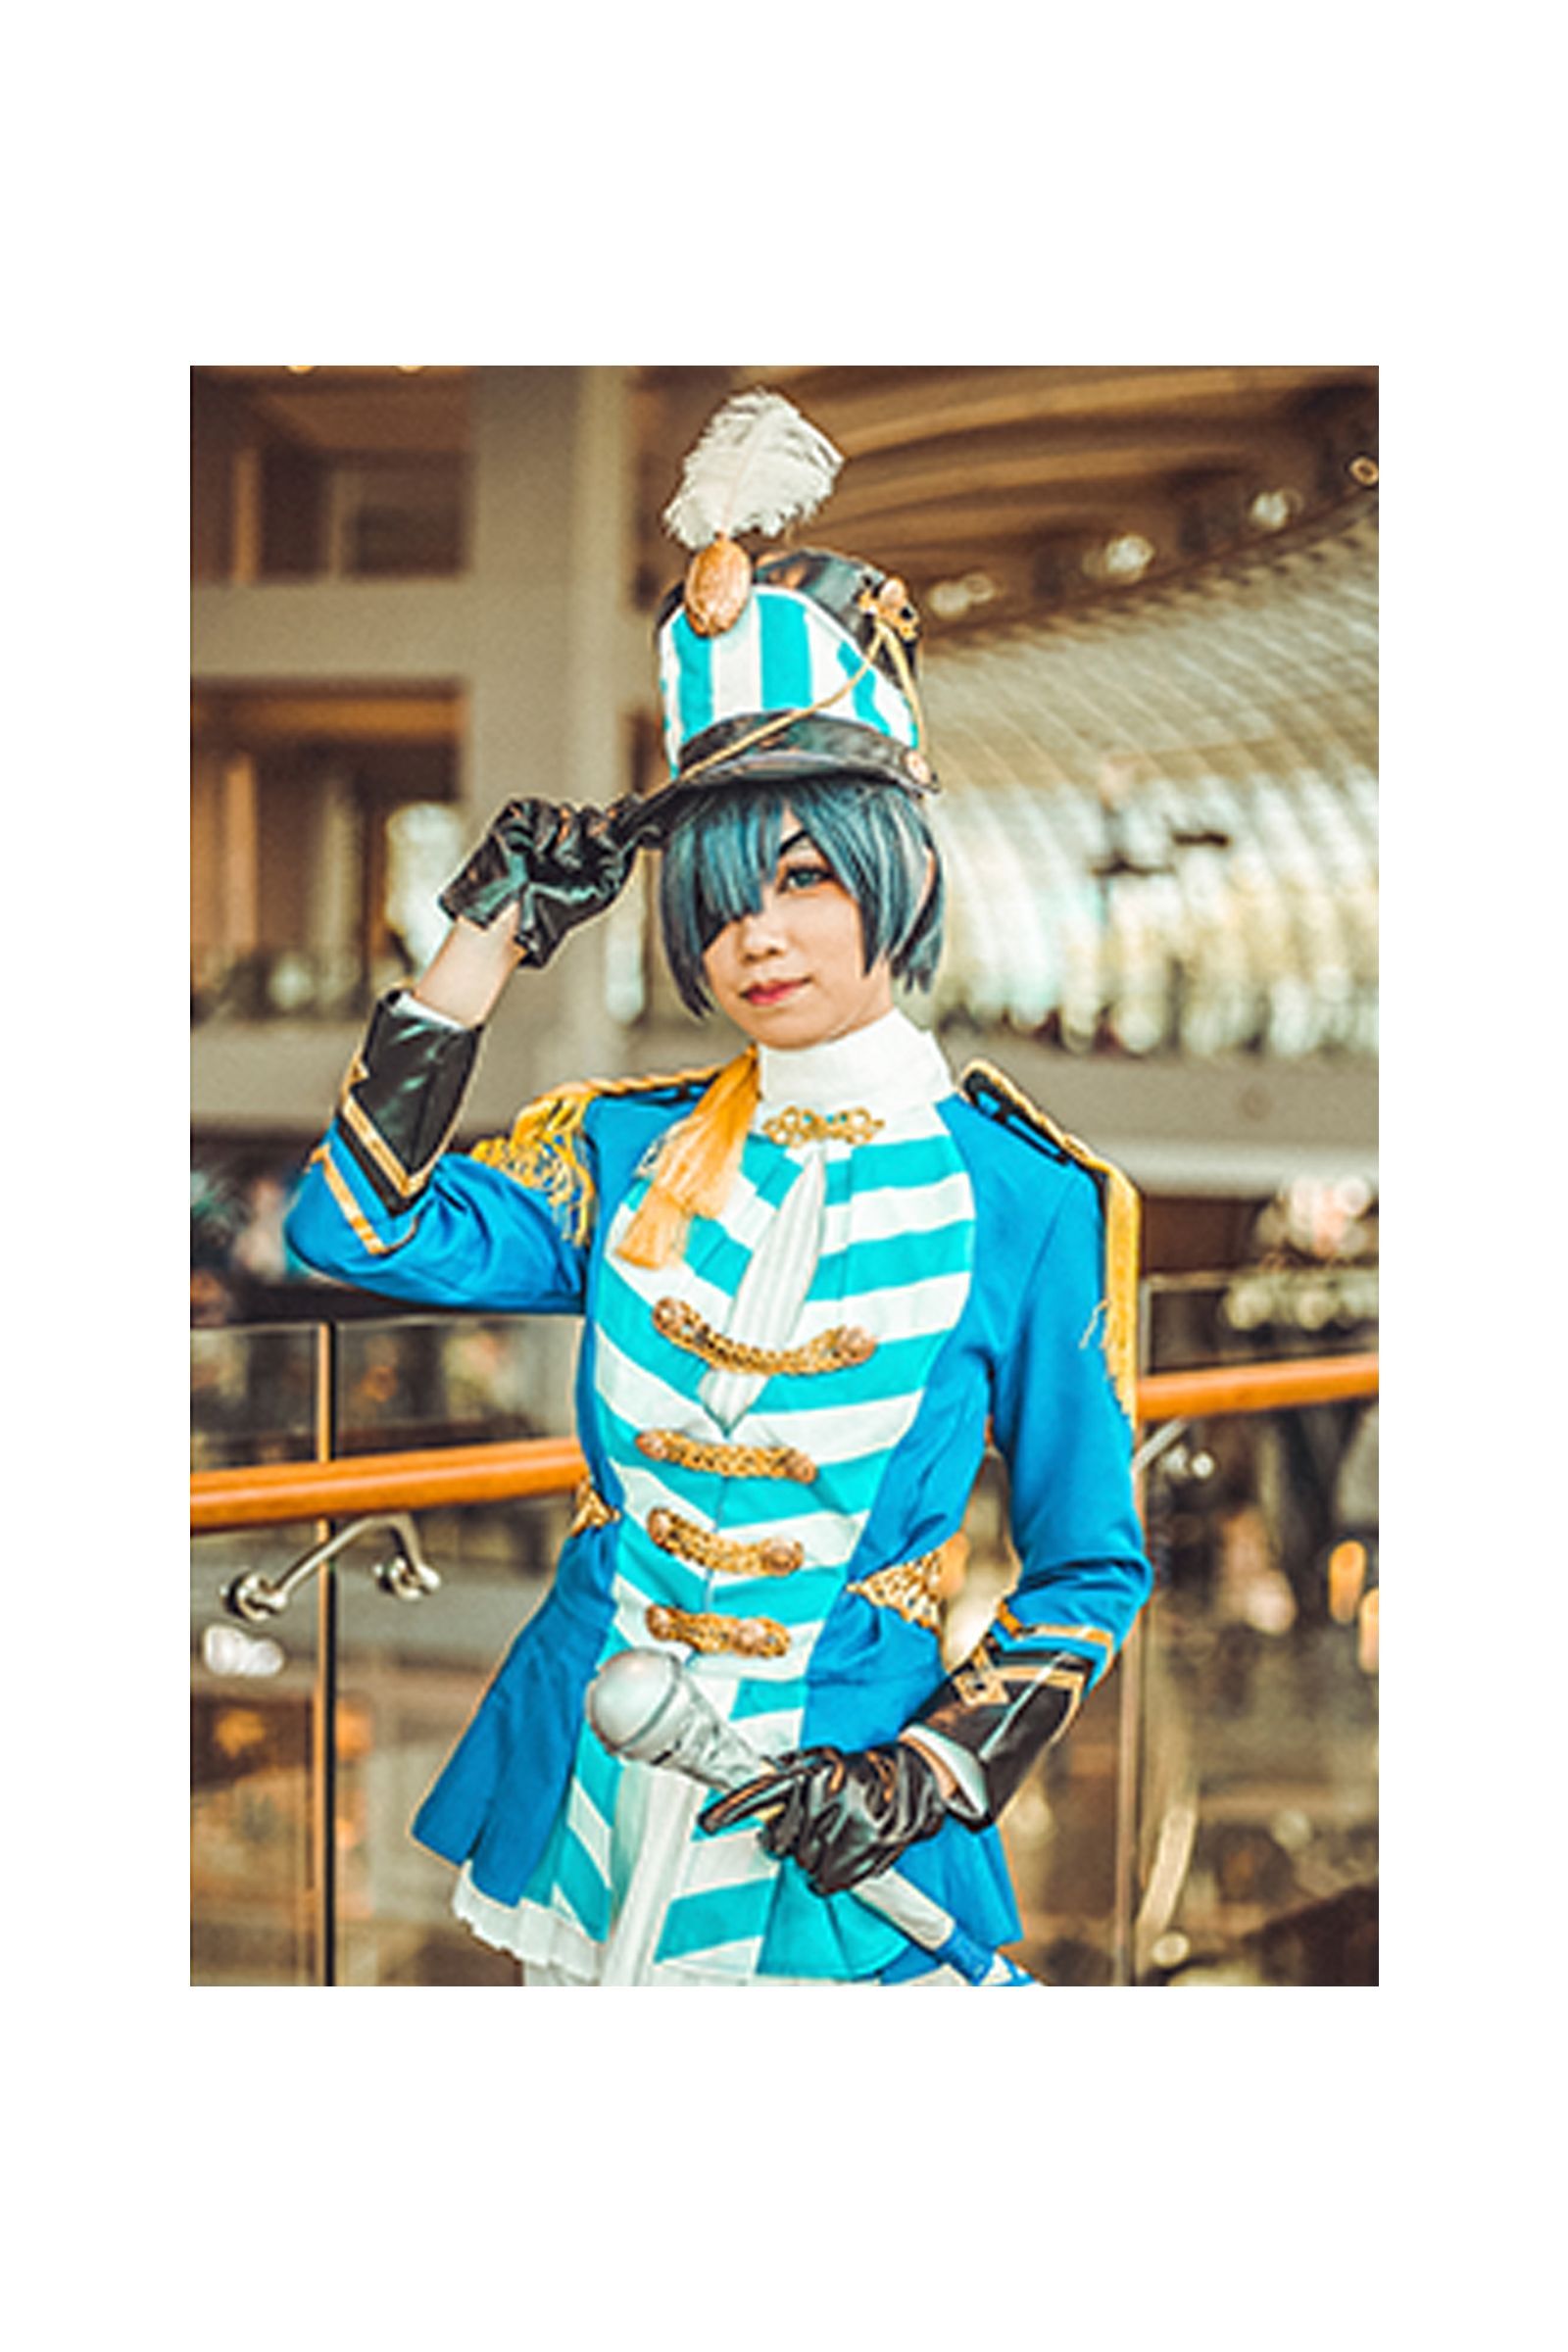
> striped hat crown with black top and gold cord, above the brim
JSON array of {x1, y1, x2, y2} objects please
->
[{"x1": 659, "y1": 551, "x2": 933, "y2": 790}]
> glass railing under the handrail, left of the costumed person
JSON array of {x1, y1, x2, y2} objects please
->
[{"x1": 190, "y1": 1498, "x2": 571, "y2": 1985}]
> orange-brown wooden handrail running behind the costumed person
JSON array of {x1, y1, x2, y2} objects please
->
[{"x1": 190, "y1": 1354, "x2": 1378, "y2": 1536}]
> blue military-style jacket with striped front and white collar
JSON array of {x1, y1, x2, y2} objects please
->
[{"x1": 289, "y1": 1011, "x2": 1150, "y2": 1983}]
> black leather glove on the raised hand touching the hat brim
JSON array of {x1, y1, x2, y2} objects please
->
[{"x1": 440, "y1": 800, "x2": 647, "y2": 966}]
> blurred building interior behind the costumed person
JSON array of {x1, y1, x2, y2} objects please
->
[{"x1": 190, "y1": 365, "x2": 1378, "y2": 1989}]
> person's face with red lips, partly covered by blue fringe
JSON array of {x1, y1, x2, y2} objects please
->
[{"x1": 703, "y1": 809, "x2": 894, "y2": 1049}]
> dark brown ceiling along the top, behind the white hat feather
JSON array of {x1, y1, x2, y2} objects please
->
[{"x1": 195, "y1": 365, "x2": 1378, "y2": 640}]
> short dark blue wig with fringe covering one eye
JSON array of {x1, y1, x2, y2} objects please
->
[{"x1": 659, "y1": 776, "x2": 945, "y2": 1013}]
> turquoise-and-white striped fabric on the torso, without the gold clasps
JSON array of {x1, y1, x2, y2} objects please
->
[{"x1": 510, "y1": 1103, "x2": 976, "y2": 1983}]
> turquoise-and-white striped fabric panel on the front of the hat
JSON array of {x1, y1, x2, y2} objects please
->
[{"x1": 659, "y1": 586, "x2": 917, "y2": 771}]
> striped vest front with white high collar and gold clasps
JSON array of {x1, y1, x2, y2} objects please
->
[{"x1": 470, "y1": 1013, "x2": 976, "y2": 1983}]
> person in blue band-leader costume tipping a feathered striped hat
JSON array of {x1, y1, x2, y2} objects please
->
[{"x1": 289, "y1": 393, "x2": 1150, "y2": 1985}]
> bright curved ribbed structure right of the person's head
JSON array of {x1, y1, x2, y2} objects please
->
[{"x1": 921, "y1": 506, "x2": 1378, "y2": 1058}]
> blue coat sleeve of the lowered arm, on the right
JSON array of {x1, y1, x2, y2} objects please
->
[{"x1": 992, "y1": 1166, "x2": 1152, "y2": 1680}]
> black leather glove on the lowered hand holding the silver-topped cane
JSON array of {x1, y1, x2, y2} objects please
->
[{"x1": 701, "y1": 1740, "x2": 948, "y2": 1895}]
